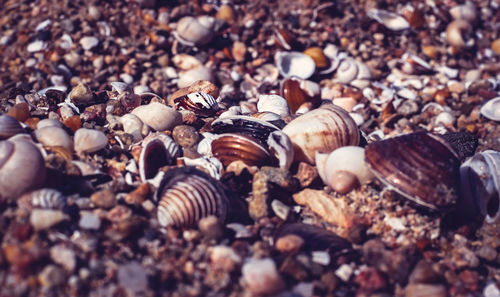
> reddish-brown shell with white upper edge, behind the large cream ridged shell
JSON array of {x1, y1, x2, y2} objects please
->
[{"x1": 281, "y1": 77, "x2": 321, "y2": 114}]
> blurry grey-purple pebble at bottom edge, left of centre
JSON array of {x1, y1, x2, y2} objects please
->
[{"x1": 117, "y1": 262, "x2": 148, "y2": 296}]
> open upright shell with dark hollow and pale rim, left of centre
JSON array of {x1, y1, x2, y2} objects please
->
[{"x1": 139, "y1": 133, "x2": 180, "y2": 181}]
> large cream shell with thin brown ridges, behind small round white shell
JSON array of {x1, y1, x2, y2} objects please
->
[{"x1": 283, "y1": 104, "x2": 359, "y2": 164}]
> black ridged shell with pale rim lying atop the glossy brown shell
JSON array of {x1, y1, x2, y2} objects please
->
[{"x1": 212, "y1": 116, "x2": 279, "y2": 146}]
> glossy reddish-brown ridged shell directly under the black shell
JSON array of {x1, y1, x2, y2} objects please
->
[{"x1": 212, "y1": 133, "x2": 271, "y2": 166}]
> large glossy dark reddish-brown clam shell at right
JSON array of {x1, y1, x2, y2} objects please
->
[{"x1": 365, "y1": 132, "x2": 460, "y2": 209}]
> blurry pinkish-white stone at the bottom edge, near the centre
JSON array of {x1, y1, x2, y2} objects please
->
[{"x1": 242, "y1": 258, "x2": 284, "y2": 295}]
